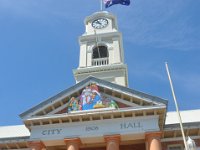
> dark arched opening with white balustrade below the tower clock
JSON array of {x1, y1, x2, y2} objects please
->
[{"x1": 92, "y1": 46, "x2": 109, "y2": 66}]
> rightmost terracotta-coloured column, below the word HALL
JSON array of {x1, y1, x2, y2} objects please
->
[{"x1": 145, "y1": 132, "x2": 162, "y2": 150}]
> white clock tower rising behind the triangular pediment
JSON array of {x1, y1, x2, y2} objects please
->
[{"x1": 73, "y1": 11, "x2": 128, "y2": 87}]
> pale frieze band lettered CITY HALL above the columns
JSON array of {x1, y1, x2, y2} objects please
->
[{"x1": 30, "y1": 116, "x2": 160, "y2": 144}]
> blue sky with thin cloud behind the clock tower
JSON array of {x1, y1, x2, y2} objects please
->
[{"x1": 0, "y1": 0, "x2": 200, "y2": 126}]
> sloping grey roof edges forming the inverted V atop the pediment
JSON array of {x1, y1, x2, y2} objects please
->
[{"x1": 20, "y1": 77, "x2": 167, "y2": 120}]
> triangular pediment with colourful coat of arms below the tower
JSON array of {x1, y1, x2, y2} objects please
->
[{"x1": 20, "y1": 77, "x2": 167, "y2": 119}]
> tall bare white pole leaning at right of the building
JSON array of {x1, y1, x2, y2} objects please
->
[{"x1": 165, "y1": 62, "x2": 189, "y2": 150}]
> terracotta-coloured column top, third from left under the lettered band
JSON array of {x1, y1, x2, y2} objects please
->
[{"x1": 104, "y1": 135, "x2": 120, "y2": 150}]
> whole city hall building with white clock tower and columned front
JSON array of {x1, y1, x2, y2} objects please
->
[{"x1": 0, "y1": 11, "x2": 200, "y2": 150}]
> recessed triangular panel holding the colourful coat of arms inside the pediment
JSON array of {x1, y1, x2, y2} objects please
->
[{"x1": 52, "y1": 92, "x2": 135, "y2": 115}]
